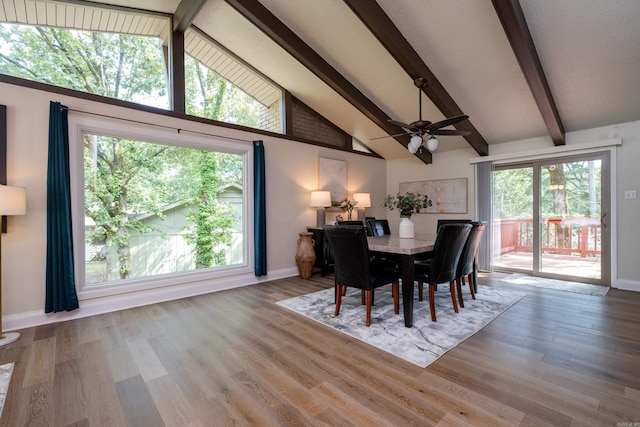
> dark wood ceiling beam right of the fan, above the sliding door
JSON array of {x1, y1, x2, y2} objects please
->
[{"x1": 492, "y1": 0, "x2": 565, "y2": 145}]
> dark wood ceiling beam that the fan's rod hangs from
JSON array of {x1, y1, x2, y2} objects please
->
[{"x1": 344, "y1": 0, "x2": 489, "y2": 156}]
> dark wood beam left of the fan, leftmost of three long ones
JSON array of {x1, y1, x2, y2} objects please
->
[{"x1": 225, "y1": 0, "x2": 432, "y2": 164}]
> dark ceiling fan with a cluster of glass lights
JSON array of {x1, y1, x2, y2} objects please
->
[{"x1": 373, "y1": 77, "x2": 471, "y2": 154}]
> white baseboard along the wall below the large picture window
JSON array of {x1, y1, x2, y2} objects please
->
[{"x1": 2, "y1": 267, "x2": 298, "y2": 331}]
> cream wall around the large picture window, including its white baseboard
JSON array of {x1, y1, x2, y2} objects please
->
[{"x1": 0, "y1": 83, "x2": 387, "y2": 330}]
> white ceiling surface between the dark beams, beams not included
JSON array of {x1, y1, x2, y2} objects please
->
[{"x1": 41, "y1": 0, "x2": 640, "y2": 159}]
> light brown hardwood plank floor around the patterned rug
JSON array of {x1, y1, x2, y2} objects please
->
[{"x1": 0, "y1": 274, "x2": 640, "y2": 427}]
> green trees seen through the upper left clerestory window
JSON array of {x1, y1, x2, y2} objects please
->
[{"x1": 0, "y1": 23, "x2": 169, "y2": 109}]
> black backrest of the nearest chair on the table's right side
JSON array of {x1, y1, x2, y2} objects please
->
[{"x1": 429, "y1": 223, "x2": 471, "y2": 285}]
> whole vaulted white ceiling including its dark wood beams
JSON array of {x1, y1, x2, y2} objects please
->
[{"x1": 16, "y1": 0, "x2": 640, "y2": 159}]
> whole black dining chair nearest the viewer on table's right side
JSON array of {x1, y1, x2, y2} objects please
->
[{"x1": 414, "y1": 224, "x2": 471, "y2": 322}]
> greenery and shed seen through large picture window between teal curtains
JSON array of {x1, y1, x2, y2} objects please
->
[{"x1": 83, "y1": 134, "x2": 244, "y2": 285}]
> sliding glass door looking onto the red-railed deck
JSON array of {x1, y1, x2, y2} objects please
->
[{"x1": 492, "y1": 153, "x2": 610, "y2": 285}]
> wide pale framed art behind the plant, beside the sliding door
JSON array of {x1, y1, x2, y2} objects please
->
[{"x1": 400, "y1": 178, "x2": 468, "y2": 213}]
